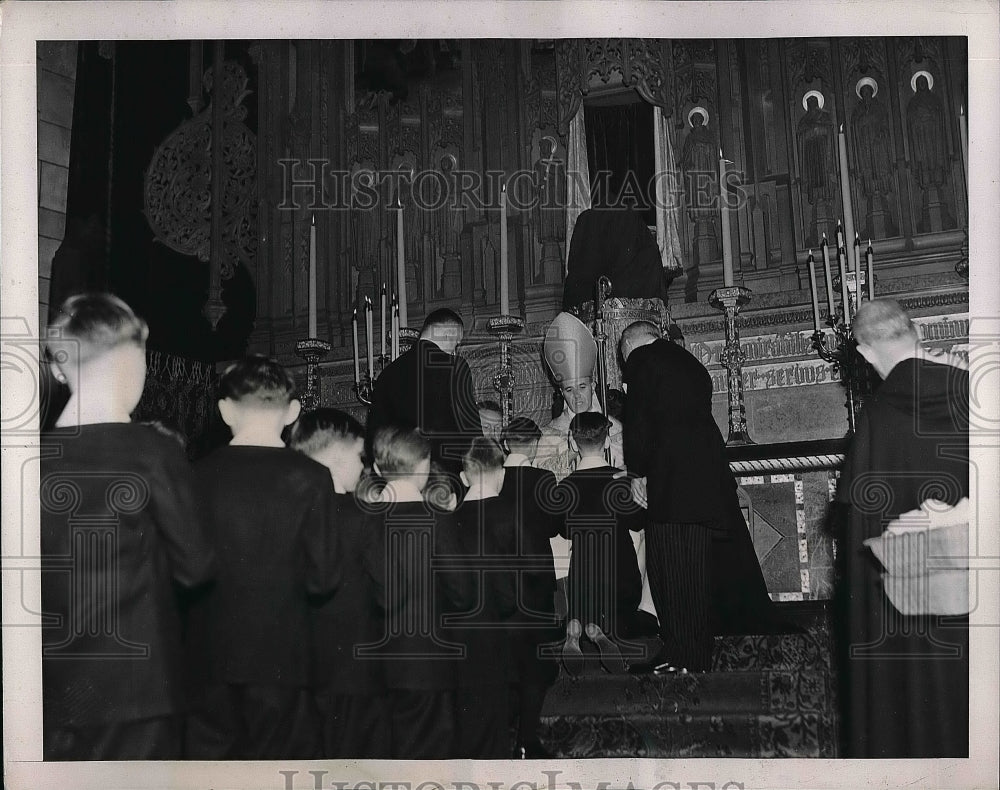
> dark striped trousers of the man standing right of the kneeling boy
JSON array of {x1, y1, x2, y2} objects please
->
[{"x1": 645, "y1": 522, "x2": 715, "y2": 672}]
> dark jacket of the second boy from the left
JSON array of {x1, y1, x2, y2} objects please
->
[{"x1": 191, "y1": 445, "x2": 341, "y2": 686}]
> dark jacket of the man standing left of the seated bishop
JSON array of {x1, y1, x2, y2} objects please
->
[{"x1": 368, "y1": 340, "x2": 483, "y2": 474}]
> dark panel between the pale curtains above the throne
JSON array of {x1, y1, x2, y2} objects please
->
[{"x1": 584, "y1": 101, "x2": 656, "y2": 225}]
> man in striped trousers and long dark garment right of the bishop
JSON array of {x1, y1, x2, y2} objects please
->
[{"x1": 621, "y1": 321, "x2": 779, "y2": 671}]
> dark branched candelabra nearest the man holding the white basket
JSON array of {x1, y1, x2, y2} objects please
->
[{"x1": 811, "y1": 270, "x2": 871, "y2": 433}]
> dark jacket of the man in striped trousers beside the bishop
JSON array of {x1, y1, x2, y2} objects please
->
[{"x1": 622, "y1": 340, "x2": 736, "y2": 524}]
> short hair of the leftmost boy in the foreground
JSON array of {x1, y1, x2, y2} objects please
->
[{"x1": 48, "y1": 293, "x2": 149, "y2": 362}]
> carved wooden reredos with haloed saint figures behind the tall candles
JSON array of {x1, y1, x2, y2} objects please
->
[{"x1": 146, "y1": 37, "x2": 968, "y2": 376}]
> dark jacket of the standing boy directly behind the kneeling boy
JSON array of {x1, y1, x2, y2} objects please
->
[{"x1": 500, "y1": 466, "x2": 562, "y2": 622}]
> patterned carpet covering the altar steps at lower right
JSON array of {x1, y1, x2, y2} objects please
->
[{"x1": 541, "y1": 604, "x2": 837, "y2": 758}]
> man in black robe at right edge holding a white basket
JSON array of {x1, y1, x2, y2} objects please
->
[{"x1": 837, "y1": 299, "x2": 969, "y2": 758}]
